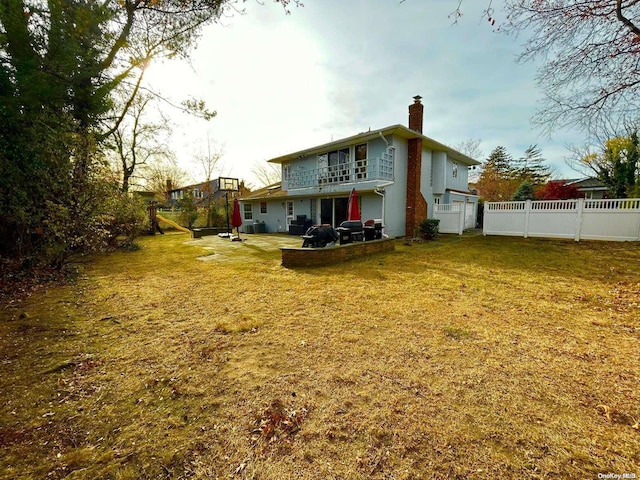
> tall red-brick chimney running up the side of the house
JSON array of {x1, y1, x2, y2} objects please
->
[{"x1": 405, "y1": 95, "x2": 427, "y2": 237}]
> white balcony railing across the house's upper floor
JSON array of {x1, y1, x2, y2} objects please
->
[{"x1": 286, "y1": 154, "x2": 393, "y2": 190}]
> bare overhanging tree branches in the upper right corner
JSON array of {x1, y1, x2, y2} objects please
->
[{"x1": 498, "y1": 0, "x2": 640, "y2": 134}]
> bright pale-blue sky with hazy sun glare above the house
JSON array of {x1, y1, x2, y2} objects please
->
[{"x1": 147, "y1": 0, "x2": 583, "y2": 186}]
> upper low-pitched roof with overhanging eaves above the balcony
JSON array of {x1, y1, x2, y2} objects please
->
[{"x1": 268, "y1": 124, "x2": 481, "y2": 165}]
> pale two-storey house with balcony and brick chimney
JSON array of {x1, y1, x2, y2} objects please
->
[{"x1": 240, "y1": 96, "x2": 480, "y2": 237}]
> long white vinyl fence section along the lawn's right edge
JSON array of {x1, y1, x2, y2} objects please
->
[{"x1": 483, "y1": 198, "x2": 640, "y2": 242}]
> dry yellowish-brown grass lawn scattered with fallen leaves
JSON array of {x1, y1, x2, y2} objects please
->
[{"x1": 0, "y1": 234, "x2": 640, "y2": 479}]
